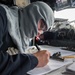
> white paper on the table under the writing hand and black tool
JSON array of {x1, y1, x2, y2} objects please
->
[{"x1": 28, "y1": 46, "x2": 75, "y2": 75}]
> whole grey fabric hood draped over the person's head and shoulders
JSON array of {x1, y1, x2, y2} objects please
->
[{"x1": 2, "y1": 2, "x2": 54, "y2": 53}]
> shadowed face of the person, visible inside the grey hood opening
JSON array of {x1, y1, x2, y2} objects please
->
[{"x1": 38, "y1": 19, "x2": 47, "y2": 35}]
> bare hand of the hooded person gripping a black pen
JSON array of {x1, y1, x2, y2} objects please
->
[{"x1": 34, "y1": 50, "x2": 50, "y2": 67}]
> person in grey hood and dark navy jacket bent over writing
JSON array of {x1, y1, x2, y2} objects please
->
[{"x1": 0, "y1": 2, "x2": 54, "y2": 75}]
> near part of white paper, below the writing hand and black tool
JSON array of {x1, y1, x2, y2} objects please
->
[{"x1": 28, "y1": 60, "x2": 72, "y2": 75}]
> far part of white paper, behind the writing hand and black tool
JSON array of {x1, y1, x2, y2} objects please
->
[{"x1": 40, "y1": 45, "x2": 75, "y2": 56}]
